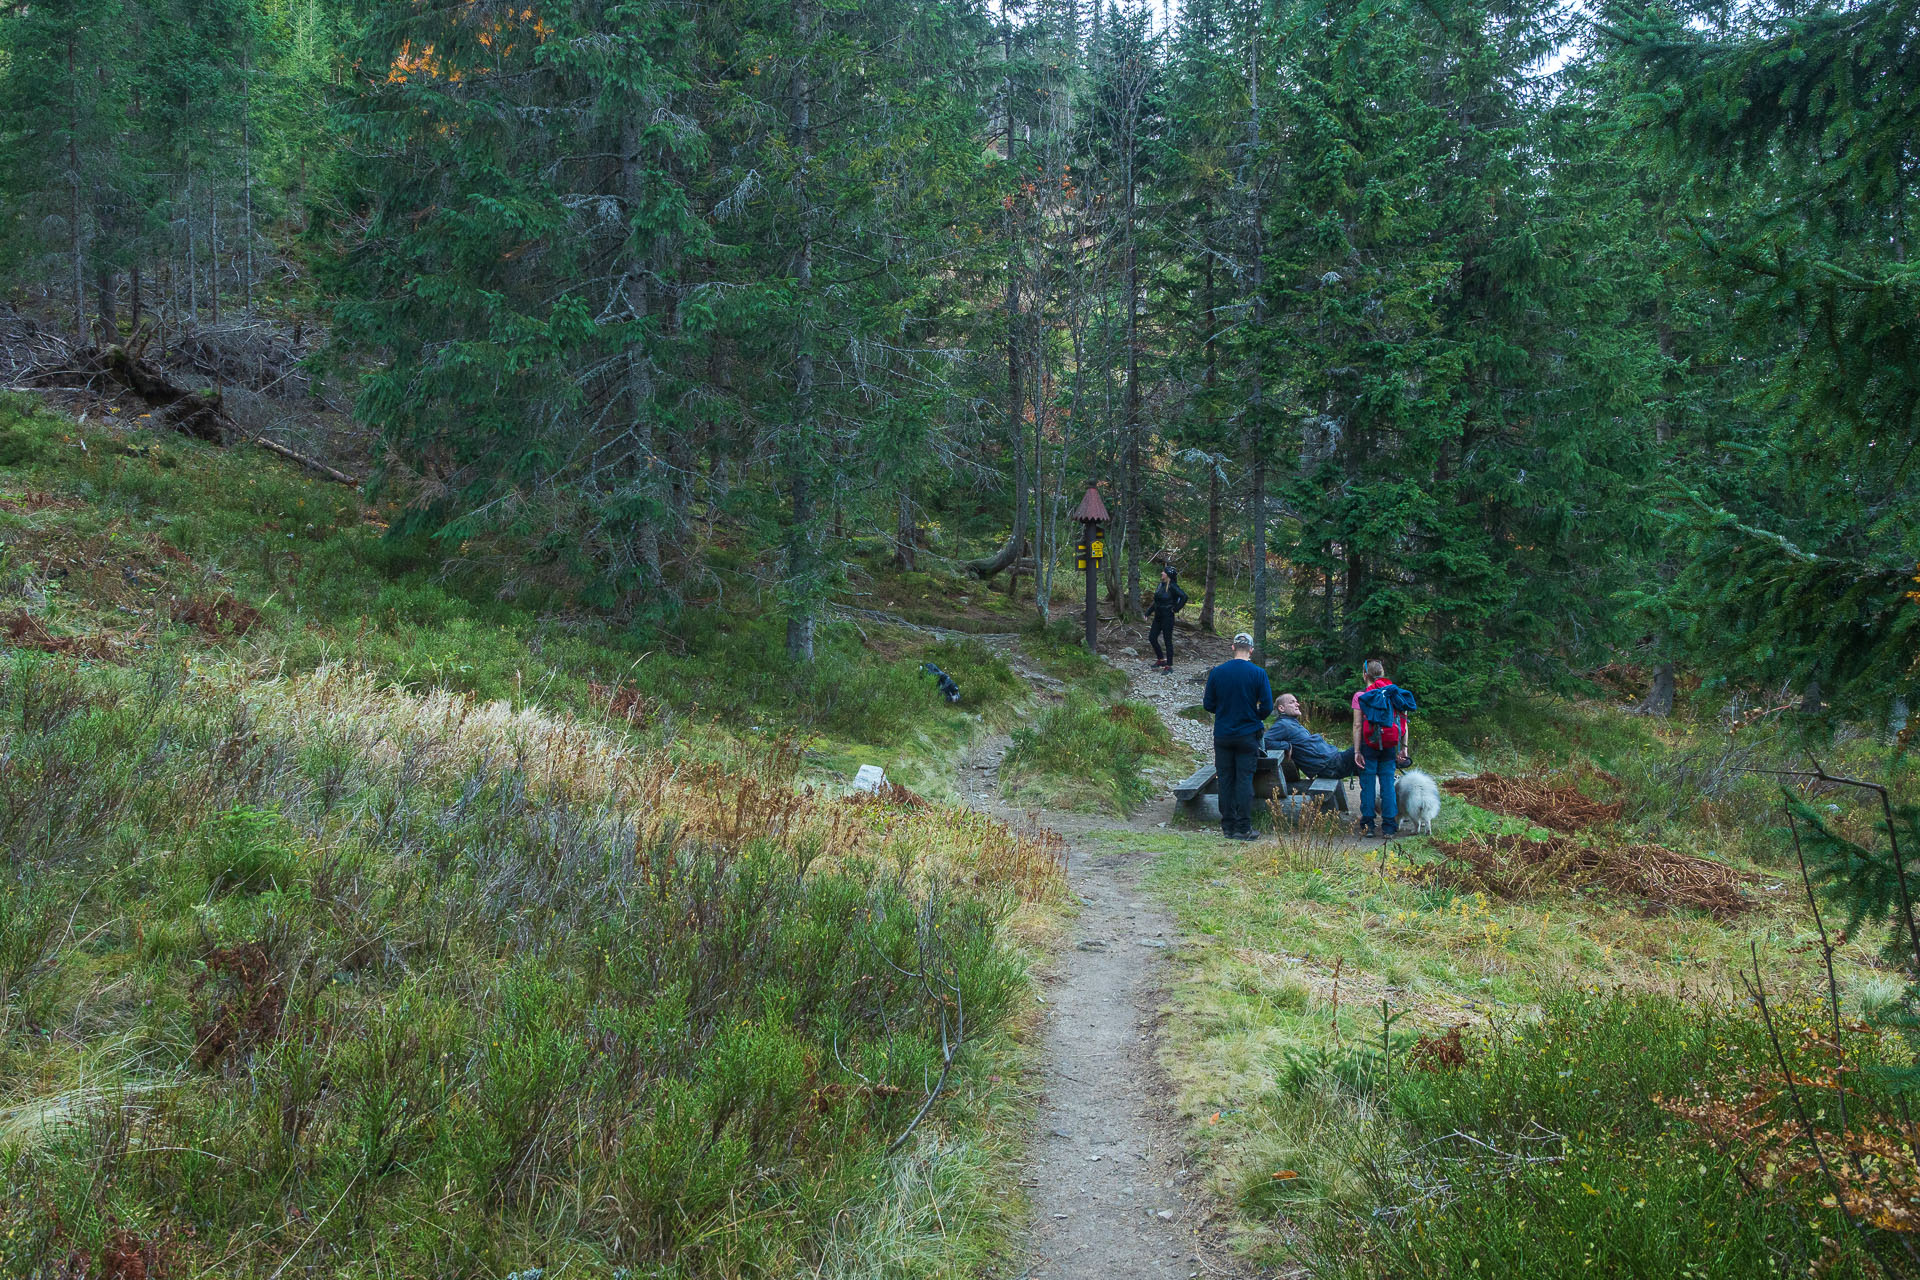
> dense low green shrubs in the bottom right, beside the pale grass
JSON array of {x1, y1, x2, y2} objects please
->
[{"x1": 1302, "y1": 992, "x2": 1872, "y2": 1280}]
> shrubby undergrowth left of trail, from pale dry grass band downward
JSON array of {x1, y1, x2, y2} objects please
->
[{"x1": 0, "y1": 654, "x2": 1062, "y2": 1276}]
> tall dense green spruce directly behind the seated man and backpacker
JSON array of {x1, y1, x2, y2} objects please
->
[{"x1": 1269, "y1": 2, "x2": 1640, "y2": 706}]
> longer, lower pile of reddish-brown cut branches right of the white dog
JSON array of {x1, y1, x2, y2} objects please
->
[{"x1": 1430, "y1": 835, "x2": 1753, "y2": 919}]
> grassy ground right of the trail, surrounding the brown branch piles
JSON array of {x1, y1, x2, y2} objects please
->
[{"x1": 1110, "y1": 690, "x2": 1912, "y2": 1276}]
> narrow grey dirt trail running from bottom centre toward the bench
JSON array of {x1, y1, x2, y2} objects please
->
[{"x1": 962, "y1": 628, "x2": 1263, "y2": 1280}]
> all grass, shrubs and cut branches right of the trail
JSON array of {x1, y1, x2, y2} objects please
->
[{"x1": 1136, "y1": 702, "x2": 1920, "y2": 1280}]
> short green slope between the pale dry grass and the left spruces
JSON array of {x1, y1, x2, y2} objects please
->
[{"x1": 0, "y1": 395, "x2": 1025, "y2": 794}]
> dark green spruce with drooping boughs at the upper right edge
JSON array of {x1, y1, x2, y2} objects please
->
[{"x1": 1609, "y1": 0, "x2": 1920, "y2": 720}]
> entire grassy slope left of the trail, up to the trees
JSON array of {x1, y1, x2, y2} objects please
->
[{"x1": 0, "y1": 401, "x2": 1062, "y2": 1276}]
